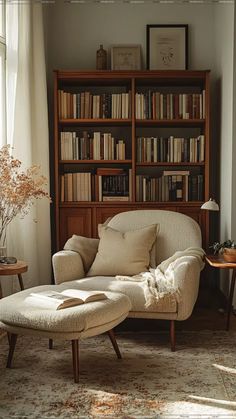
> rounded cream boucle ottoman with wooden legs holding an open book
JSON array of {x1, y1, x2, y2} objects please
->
[{"x1": 0, "y1": 285, "x2": 131, "y2": 382}]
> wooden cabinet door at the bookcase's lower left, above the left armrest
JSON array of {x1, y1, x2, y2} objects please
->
[{"x1": 60, "y1": 208, "x2": 92, "y2": 248}]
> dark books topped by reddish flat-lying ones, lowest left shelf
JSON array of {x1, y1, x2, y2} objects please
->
[{"x1": 95, "y1": 168, "x2": 131, "y2": 201}]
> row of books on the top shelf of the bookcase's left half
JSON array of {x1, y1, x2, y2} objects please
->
[{"x1": 58, "y1": 90, "x2": 131, "y2": 119}]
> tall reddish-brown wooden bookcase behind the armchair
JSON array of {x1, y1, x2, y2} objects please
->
[{"x1": 54, "y1": 70, "x2": 210, "y2": 250}]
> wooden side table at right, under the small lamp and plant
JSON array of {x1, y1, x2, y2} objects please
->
[{"x1": 205, "y1": 255, "x2": 236, "y2": 330}]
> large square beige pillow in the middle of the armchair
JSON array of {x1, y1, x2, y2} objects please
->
[{"x1": 87, "y1": 224, "x2": 157, "y2": 276}]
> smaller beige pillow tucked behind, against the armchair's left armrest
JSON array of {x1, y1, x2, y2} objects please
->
[{"x1": 64, "y1": 234, "x2": 99, "y2": 272}]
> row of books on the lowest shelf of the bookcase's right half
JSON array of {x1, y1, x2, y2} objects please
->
[{"x1": 136, "y1": 171, "x2": 204, "y2": 202}]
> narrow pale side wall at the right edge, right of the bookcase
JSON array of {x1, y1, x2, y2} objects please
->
[{"x1": 213, "y1": 5, "x2": 236, "y2": 303}]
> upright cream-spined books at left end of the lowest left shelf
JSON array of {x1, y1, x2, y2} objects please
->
[{"x1": 61, "y1": 172, "x2": 92, "y2": 202}]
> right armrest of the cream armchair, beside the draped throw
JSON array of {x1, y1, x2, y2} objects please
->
[{"x1": 172, "y1": 257, "x2": 201, "y2": 320}]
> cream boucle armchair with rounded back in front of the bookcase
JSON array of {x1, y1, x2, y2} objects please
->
[{"x1": 53, "y1": 210, "x2": 202, "y2": 351}]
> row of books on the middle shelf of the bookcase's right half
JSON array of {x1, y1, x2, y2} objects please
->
[{"x1": 136, "y1": 135, "x2": 205, "y2": 163}]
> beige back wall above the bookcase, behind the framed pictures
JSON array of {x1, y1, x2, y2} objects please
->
[{"x1": 45, "y1": 0, "x2": 214, "y2": 74}]
